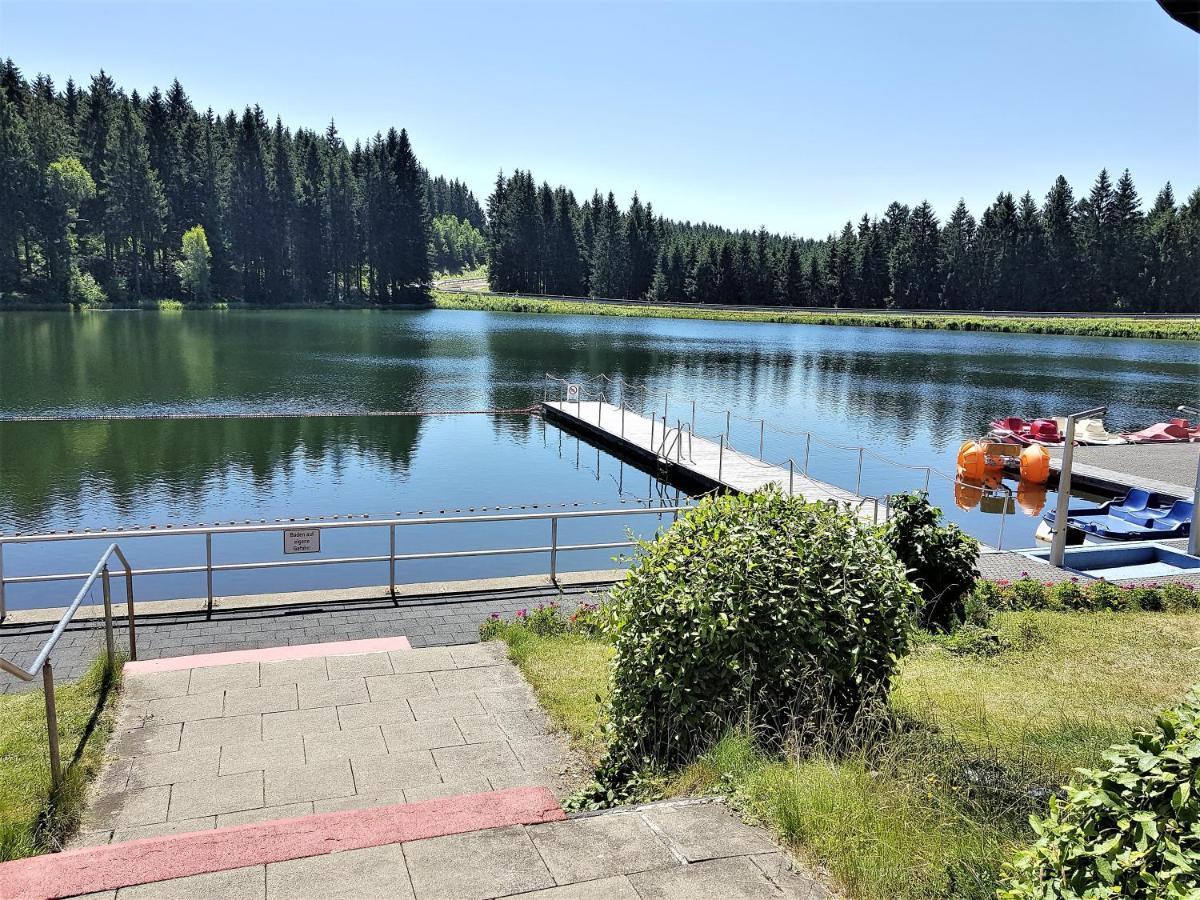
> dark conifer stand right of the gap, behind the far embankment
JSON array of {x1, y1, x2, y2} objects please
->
[{"x1": 487, "y1": 172, "x2": 1200, "y2": 313}]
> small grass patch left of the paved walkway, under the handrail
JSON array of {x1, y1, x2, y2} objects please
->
[{"x1": 0, "y1": 659, "x2": 120, "y2": 860}]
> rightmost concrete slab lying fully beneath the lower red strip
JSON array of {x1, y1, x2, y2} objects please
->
[{"x1": 404, "y1": 826, "x2": 554, "y2": 900}]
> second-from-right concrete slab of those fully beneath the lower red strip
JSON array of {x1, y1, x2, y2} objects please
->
[{"x1": 266, "y1": 844, "x2": 413, "y2": 900}]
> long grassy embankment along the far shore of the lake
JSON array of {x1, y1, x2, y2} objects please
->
[{"x1": 432, "y1": 290, "x2": 1200, "y2": 341}]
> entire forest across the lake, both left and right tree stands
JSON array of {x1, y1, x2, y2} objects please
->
[{"x1": 0, "y1": 61, "x2": 1200, "y2": 312}]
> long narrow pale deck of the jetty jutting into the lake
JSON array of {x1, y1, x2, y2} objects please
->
[{"x1": 541, "y1": 400, "x2": 887, "y2": 521}]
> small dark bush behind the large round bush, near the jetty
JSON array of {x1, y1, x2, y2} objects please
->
[{"x1": 883, "y1": 491, "x2": 979, "y2": 631}]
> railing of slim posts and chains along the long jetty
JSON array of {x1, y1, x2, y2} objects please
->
[{"x1": 544, "y1": 372, "x2": 1012, "y2": 550}]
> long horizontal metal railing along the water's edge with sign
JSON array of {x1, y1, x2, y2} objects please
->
[{"x1": 0, "y1": 505, "x2": 690, "y2": 618}]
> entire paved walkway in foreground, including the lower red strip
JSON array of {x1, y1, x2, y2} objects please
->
[{"x1": 0, "y1": 637, "x2": 829, "y2": 900}]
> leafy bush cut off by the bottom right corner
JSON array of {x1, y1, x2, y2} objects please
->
[{"x1": 1000, "y1": 690, "x2": 1200, "y2": 900}]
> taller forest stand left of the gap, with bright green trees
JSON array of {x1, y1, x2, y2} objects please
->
[{"x1": 0, "y1": 60, "x2": 484, "y2": 304}]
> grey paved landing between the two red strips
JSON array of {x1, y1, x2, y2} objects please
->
[{"x1": 77, "y1": 638, "x2": 587, "y2": 844}]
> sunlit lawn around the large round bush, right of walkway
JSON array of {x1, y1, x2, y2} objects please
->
[{"x1": 484, "y1": 612, "x2": 1200, "y2": 899}]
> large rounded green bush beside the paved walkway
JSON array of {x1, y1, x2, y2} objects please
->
[{"x1": 602, "y1": 490, "x2": 918, "y2": 774}]
